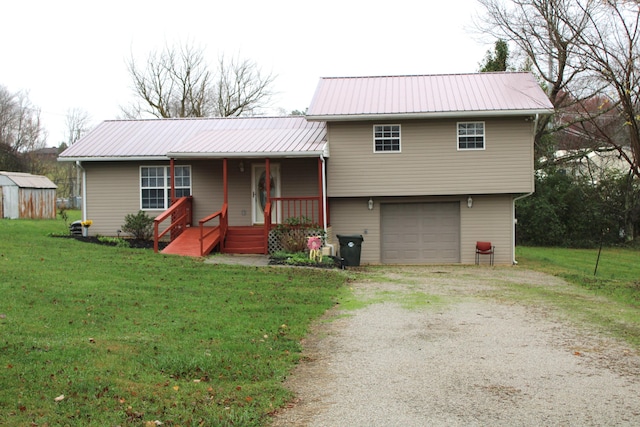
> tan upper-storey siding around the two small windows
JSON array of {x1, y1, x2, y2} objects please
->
[{"x1": 328, "y1": 117, "x2": 533, "y2": 197}]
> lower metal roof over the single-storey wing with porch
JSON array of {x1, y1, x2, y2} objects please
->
[{"x1": 59, "y1": 116, "x2": 326, "y2": 161}]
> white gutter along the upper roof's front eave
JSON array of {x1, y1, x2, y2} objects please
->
[{"x1": 305, "y1": 108, "x2": 553, "y2": 122}]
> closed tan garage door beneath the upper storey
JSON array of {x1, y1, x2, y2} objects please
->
[{"x1": 381, "y1": 202, "x2": 460, "y2": 264}]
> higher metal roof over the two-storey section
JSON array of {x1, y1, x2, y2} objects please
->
[{"x1": 307, "y1": 72, "x2": 553, "y2": 121}]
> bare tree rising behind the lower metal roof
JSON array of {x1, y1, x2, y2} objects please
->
[{"x1": 122, "y1": 44, "x2": 274, "y2": 118}]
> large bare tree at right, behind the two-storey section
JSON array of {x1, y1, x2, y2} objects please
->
[{"x1": 479, "y1": 0, "x2": 640, "y2": 176}]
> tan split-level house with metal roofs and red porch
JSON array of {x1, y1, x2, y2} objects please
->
[{"x1": 59, "y1": 73, "x2": 553, "y2": 264}]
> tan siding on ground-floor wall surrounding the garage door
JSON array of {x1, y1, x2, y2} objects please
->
[{"x1": 329, "y1": 195, "x2": 513, "y2": 265}]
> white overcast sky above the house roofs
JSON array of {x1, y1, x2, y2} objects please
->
[{"x1": 0, "y1": 0, "x2": 492, "y2": 146}]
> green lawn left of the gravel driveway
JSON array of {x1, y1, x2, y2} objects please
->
[{"x1": 0, "y1": 212, "x2": 347, "y2": 426}]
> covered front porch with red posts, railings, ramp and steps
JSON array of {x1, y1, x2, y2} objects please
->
[{"x1": 154, "y1": 155, "x2": 328, "y2": 256}]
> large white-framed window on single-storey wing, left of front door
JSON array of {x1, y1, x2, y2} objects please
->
[{"x1": 140, "y1": 166, "x2": 191, "y2": 209}]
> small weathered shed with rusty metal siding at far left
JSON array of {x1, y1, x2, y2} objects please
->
[{"x1": 0, "y1": 172, "x2": 57, "y2": 219}]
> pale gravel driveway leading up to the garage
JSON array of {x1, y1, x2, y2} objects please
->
[{"x1": 273, "y1": 267, "x2": 640, "y2": 427}]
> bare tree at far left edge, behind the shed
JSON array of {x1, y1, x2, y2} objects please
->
[{"x1": 0, "y1": 85, "x2": 46, "y2": 172}]
